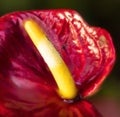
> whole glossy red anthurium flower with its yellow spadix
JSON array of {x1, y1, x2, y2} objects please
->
[{"x1": 0, "y1": 10, "x2": 115, "y2": 117}]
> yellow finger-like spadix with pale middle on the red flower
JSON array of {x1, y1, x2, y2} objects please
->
[{"x1": 24, "y1": 19, "x2": 77, "y2": 99}]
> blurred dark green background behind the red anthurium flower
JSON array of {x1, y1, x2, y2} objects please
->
[{"x1": 0, "y1": 0, "x2": 120, "y2": 117}]
